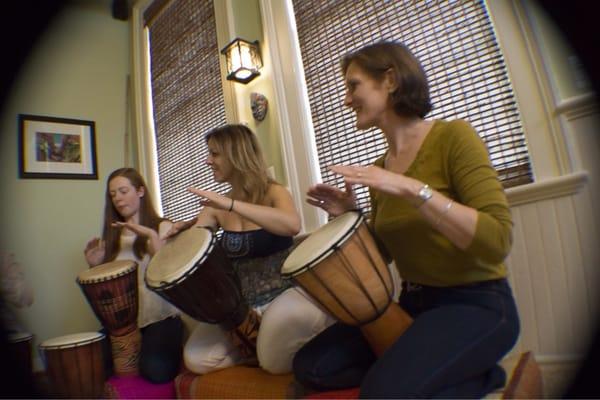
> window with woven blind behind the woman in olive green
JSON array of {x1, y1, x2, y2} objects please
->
[{"x1": 292, "y1": 0, "x2": 532, "y2": 216}]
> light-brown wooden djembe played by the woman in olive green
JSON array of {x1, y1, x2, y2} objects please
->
[{"x1": 281, "y1": 211, "x2": 412, "y2": 356}]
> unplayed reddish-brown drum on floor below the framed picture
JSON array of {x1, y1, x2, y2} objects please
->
[{"x1": 39, "y1": 332, "x2": 106, "y2": 399}]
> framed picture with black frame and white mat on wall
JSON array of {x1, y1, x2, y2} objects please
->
[{"x1": 18, "y1": 114, "x2": 98, "y2": 179}]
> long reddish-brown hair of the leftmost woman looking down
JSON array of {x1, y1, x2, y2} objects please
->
[{"x1": 102, "y1": 168, "x2": 165, "y2": 263}]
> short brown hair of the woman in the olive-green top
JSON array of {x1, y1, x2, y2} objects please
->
[{"x1": 341, "y1": 41, "x2": 432, "y2": 118}]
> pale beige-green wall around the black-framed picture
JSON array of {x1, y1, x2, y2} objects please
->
[{"x1": 0, "y1": 1, "x2": 129, "y2": 368}]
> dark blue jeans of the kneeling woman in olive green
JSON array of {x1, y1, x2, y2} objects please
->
[{"x1": 293, "y1": 279, "x2": 519, "y2": 399}]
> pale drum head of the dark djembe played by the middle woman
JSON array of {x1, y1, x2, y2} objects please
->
[{"x1": 146, "y1": 226, "x2": 216, "y2": 288}]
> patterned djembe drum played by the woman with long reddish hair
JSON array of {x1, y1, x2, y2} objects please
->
[{"x1": 77, "y1": 260, "x2": 142, "y2": 376}]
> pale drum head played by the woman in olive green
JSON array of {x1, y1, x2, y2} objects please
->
[{"x1": 281, "y1": 211, "x2": 364, "y2": 278}]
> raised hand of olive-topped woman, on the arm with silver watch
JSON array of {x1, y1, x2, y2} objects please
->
[{"x1": 329, "y1": 165, "x2": 406, "y2": 196}]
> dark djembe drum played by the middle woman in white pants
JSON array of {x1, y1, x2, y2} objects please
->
[{"x1": 145, "y1": 226, "x2": 260, "y2": 362}]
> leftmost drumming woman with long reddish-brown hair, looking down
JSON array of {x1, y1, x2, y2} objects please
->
[{"x1": 84, "y1": 168, "x2": 183, "y2": 383}]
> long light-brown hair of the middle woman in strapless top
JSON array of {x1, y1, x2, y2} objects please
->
[{"x1": 206, "y1": 124, "x2": 277, "y2": 204}]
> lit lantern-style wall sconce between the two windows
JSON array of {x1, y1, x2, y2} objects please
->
[{"x1": 221, "y1": 38, "x2": 262, "y2": 84}]
